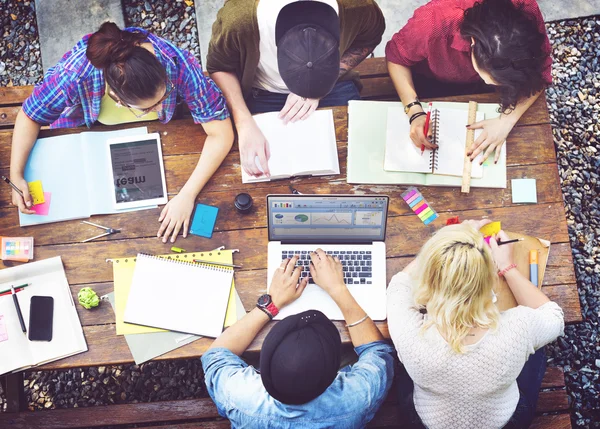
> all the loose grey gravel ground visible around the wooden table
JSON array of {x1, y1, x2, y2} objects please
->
[{"x1": 0, "y1": 0, "x2": 600, "y2": 428}]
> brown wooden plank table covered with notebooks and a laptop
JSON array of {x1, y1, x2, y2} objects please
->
[{"x1": 0, "y1": 88, "x2": 581, "y2": 428}]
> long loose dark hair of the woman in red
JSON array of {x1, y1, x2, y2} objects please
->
[{"x1": 460, "y1": 0, "x2": 546, "y2": 113}]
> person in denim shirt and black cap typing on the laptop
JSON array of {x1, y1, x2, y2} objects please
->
[{"x1": 202, "y1": 249, "x2": 394, "y2": 429}]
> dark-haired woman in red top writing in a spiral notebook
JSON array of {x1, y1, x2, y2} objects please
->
[{"x1": 385, "y1": 0, "x2": 552, "y2": 162}]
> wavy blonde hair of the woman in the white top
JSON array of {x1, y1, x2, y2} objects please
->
[{"x1": 414, "y1": 224, "x2": 500, "y2": 353}]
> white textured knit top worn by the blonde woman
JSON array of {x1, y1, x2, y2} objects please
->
[{"x1": 387, "y1": 273, "x2": 565, "y2": 429}]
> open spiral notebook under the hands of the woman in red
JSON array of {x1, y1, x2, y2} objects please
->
[{"x1": 383, "y1": 106, "x2": 484, "y2": 178}]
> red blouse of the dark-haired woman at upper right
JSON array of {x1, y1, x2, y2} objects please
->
[{"x1": 385, "y1": 0, "x2": 552, "y2": 85}]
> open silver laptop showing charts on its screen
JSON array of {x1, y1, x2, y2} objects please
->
[{"x1": 267, "y1": 195, "x2": 389, "y2": 320}]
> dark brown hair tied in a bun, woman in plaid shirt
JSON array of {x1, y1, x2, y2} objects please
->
[{"x1": 86, "y1": 22, "x2": 167, "y2": 104}]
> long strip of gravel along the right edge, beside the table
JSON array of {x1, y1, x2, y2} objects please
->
[{"x1": 546, "y1": 17, "x2": 600, "y2": 427}]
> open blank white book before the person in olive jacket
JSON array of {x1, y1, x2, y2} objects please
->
[{"x1": 242, "y1": 110, "x2": 340, "y2": 183}]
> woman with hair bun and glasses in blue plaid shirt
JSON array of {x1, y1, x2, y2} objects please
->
[{"x1": 10, "y1": 22, "x2": 233, "y2": 242}]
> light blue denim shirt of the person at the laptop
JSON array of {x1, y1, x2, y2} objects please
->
[{"x1": 202, "y1": 341, "x2": 394, "y2": 429}]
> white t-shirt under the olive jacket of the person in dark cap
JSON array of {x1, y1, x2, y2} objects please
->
[{"x1": 253, "y1": 0, "x2": 339, "y2": 94}]
